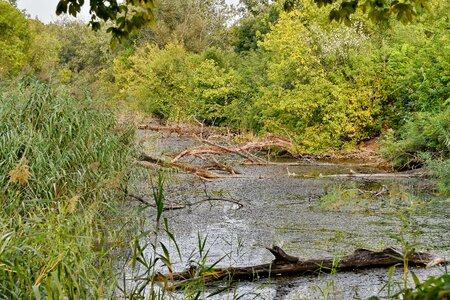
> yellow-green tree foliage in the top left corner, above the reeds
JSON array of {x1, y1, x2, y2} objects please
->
[{"x1": 0, "y1": 0, "x2": 30, "y2": 79}]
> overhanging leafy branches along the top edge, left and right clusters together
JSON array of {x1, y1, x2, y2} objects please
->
[{"x1": 56, "y1": 0, "x2": 428, "y2": 44}]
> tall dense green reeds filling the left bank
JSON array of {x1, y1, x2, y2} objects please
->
[{"x1": 0, "y1": 79, "x2": 133, "y2": 299}]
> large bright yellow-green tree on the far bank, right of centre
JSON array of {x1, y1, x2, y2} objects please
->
[{"x1": 253, "y1": 13, "x2": 382, "y2": 153}]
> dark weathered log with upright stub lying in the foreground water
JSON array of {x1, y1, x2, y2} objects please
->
[{"x1": 153, "y1": 246, "x2": 444, "y2": 289}]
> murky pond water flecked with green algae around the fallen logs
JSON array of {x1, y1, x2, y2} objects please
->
[{"x1": 140, "y1": 132, "x2": 450, "y2": 299}]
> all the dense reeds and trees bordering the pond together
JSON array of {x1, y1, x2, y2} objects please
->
[{"x1": 0, "y1": 0, "x2": 450, "y2": 299}]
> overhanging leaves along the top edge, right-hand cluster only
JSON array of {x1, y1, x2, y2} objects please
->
[{"x1": 283, "y1": 0, "x2": 430, "y2": 25}]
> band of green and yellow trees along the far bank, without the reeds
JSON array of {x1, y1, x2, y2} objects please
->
[{"x1": 0, "y1": 0, "x2": 450, "y2": 185}]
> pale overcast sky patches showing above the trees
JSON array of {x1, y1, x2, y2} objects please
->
[{"x1": 17, "y1": 0, "x2": 239, "y2": 23}]
